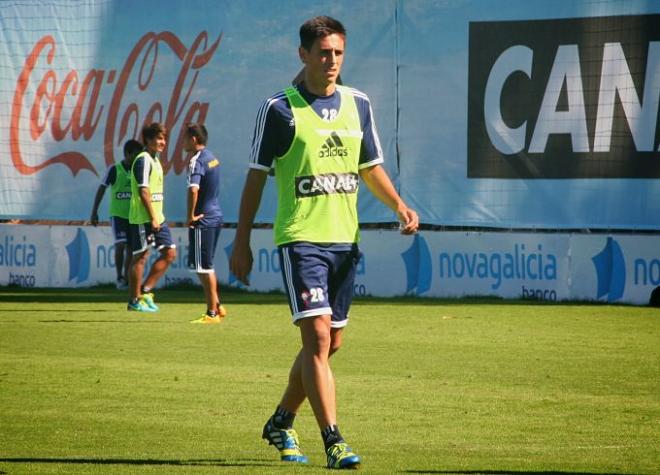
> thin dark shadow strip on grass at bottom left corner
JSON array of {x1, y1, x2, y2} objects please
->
[{"x1": 0, "y1": 457, "x2": 279, "y2": 473}]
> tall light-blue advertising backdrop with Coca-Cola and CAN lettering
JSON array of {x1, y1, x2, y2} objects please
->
[{"x1": 0, "y1": 0, "x2": 660, "y2": 230}]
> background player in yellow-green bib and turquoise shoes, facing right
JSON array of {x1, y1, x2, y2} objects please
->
[{"x1": 128, "y1": 122, "x2": 176, "y2": 312}]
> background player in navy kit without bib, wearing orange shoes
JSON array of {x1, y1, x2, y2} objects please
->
[{"x1": 183, "y1": 124, "x2": 227, "y2": 323}]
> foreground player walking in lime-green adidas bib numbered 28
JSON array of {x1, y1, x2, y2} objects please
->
[{"x1": 230, "y1": 16, "x2": 419, "y2": 468}]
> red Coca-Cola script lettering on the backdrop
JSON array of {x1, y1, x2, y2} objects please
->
[{"x1": 9, "y1": 31, "x2": 222, "y2": 176}]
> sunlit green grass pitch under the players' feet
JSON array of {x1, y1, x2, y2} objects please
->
[{"x1": 0, "y1": 288, "x2": 660, "y2": 474}]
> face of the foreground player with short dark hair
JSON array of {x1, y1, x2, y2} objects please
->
[{"x1": 299, "y1": 33, "x2": 345, "y2": 92}]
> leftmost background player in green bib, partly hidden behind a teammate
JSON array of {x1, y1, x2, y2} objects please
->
[{"x1": 89, "y1": 140, "x2": 142, "y2": 290}]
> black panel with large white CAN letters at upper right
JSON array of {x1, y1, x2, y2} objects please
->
[{"x1": 467, "y1": 14, "x2": 660, "y2": 179}]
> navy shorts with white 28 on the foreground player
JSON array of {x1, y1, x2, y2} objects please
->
[{"x1": 278, "y1": 242, "x2": 361, "y2": 328}]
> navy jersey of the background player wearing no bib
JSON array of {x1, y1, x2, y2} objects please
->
[{"x1": 188, "y1": 148, "x2": 222, "y2": 227}]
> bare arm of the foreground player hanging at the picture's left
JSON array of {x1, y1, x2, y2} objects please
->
[{"x1": 229, "y1": 168, "x2": 268, "y2": 285}]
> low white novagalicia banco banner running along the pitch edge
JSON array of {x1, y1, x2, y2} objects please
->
[{"x1": 0, "y1": 224, "x2": 660, "y2": 305}]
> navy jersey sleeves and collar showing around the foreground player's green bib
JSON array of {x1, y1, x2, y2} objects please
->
[{"x1": 250, "y1": 84, "x2": 383, "y2": 171}]
